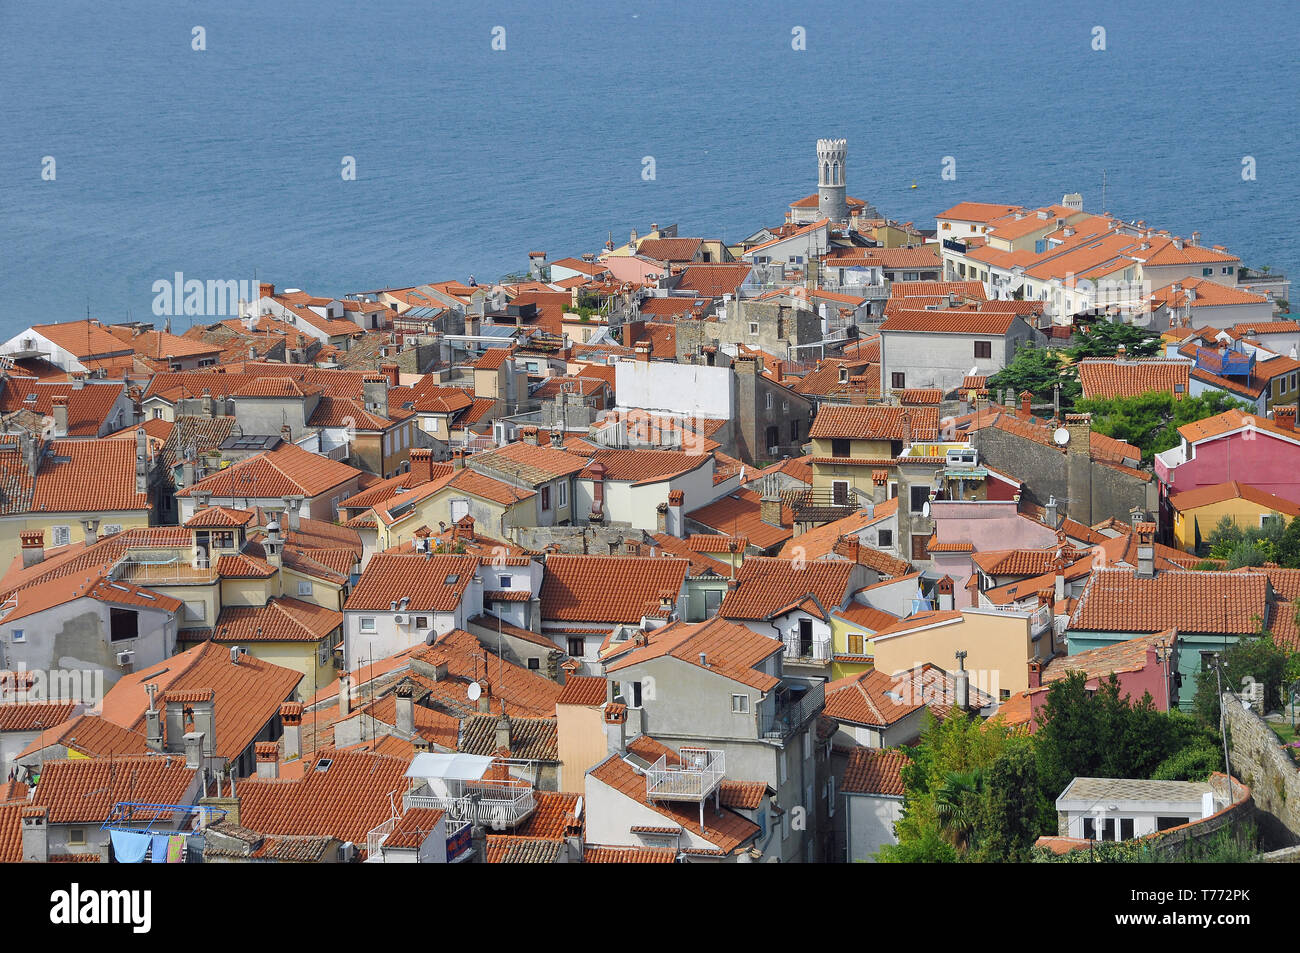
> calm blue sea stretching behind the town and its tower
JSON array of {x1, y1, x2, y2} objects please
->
[{"x1": 0, "y1": 0, "x2": 1300, "y2": 337}]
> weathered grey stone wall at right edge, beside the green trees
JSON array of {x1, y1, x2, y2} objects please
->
[{"x1": 1223, "y1": 694, "x2": 1300, "y2": 846}]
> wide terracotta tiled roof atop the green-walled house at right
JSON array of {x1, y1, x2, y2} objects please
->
[{"x1": 1070, "y1": 568, "x2": 1269, "y2": 636}]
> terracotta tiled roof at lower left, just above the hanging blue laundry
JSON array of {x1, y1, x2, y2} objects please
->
[{"x1": 34, "y1": 754, "x2": 196, "y2": 824}]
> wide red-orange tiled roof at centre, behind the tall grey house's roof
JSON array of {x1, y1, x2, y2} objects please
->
[{"x1": 541, "y1": 555, "x2": 686, "y2": 624}]
